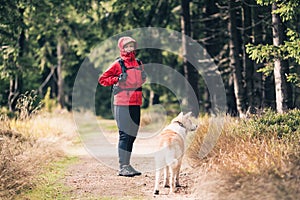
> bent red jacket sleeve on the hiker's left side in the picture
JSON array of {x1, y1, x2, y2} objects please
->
[{"x1": 98, "y1": 62, "x2": 121, "y2": 86}]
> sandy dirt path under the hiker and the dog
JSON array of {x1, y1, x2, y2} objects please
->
[{"x1": 64, "y1": 130, "x2": 195, "y2": 200}]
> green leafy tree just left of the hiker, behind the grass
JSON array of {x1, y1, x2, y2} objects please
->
[{"x1": 28, "y1": 0, "x2": 101, "y2": 108}]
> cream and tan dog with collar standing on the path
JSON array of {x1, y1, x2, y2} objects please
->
[{"x1": 154, "y1": 112, "x2": 197, "y2": 195}]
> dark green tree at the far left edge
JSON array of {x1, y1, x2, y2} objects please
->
[{"x1": 0, "y1": 0, "x2": 37, "y2": 111}]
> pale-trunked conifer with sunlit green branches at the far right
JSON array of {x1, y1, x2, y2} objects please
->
[{"x1": 247, "y1": 0, "x2": 300, "y2": 113}]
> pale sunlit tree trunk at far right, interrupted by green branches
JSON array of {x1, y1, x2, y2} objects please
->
[{"x1": 272, "y1": 3, "x2": 289, "y2": 113}]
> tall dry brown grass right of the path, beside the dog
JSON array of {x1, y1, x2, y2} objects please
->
[{"x1": 187, "y1": 111, "x2": 300, "y2": 199}]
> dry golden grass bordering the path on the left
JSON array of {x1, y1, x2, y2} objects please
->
[{"x1": 0, "y1": 110, "x2": 74, "y2": 199}]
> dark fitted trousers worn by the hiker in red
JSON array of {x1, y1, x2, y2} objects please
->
[{"x1": 114, "y1": 106, "x2": 141, "y2": 167}]
